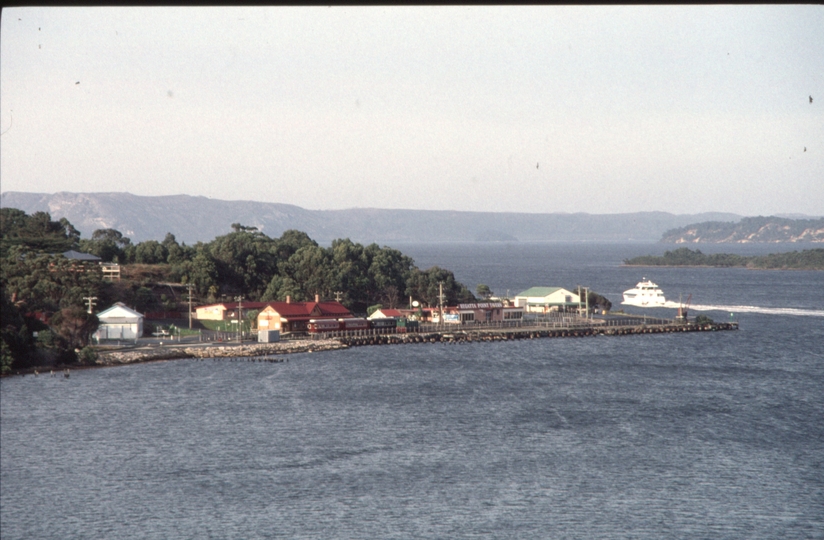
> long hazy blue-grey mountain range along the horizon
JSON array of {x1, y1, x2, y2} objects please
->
[{"x1": 0, "y1": 192, "x2": 741, "y2": 244}]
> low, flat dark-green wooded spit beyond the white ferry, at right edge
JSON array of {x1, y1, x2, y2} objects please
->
[{"x1": 624, "y1": 248, "x2": 824, "y2": 270}]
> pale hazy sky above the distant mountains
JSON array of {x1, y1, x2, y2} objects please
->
[{"x1": 0, "y1": 5, "x2": 824, "y2": 215}]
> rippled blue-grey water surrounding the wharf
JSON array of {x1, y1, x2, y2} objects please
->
[{"x1": 0, "y1": 244, "x2": 824, "y2": 539}]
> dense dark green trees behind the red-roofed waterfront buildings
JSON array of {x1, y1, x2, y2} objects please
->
[{"x1": 0, "y1": 208, "x2": 476, "y2": 374}]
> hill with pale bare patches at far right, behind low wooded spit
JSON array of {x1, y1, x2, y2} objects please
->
[{"x1": 661, "y1": 216, "x2": 824, "y2": 244}]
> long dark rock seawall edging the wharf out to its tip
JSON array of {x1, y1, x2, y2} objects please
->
[{"x1": 337, "y1": 323, "x2": 738, "y2": 347}]
